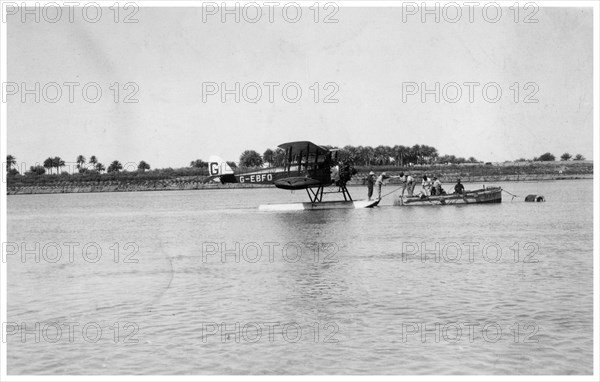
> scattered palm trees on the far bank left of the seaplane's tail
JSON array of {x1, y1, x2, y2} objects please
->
[{"x1": 6, "y1": 155, "x2": 150, "y2": 175}]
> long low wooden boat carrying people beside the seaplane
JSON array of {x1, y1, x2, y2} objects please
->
[{"x1": 394, "y1": 187, "x2": 502, "y2": 206}]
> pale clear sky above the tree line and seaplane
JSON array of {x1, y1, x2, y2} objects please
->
[{"x1": 3, "y1": 7, "x2": 593, "y2": 168}]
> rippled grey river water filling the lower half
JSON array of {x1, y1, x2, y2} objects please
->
[{"x1": 7, "y1": 180, "x2": 593, "y2": 374}]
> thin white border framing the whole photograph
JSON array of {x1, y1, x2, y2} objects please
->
[{"x1": 0, "y1": 0, "x2": 600, "y2": 382}]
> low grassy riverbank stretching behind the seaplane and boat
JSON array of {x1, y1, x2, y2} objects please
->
[{"x1": 7, "y1": 161, "x2": 594, "y2": 195}]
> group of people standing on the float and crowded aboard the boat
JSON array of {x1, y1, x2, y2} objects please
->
[{"x1": 366, "y1": 171, "x2": 465, "y2": 200}]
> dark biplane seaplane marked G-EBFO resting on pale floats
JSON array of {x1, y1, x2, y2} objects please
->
[{"x1": 203, "y1": 141, "x2": 379, "y2": 211}]
